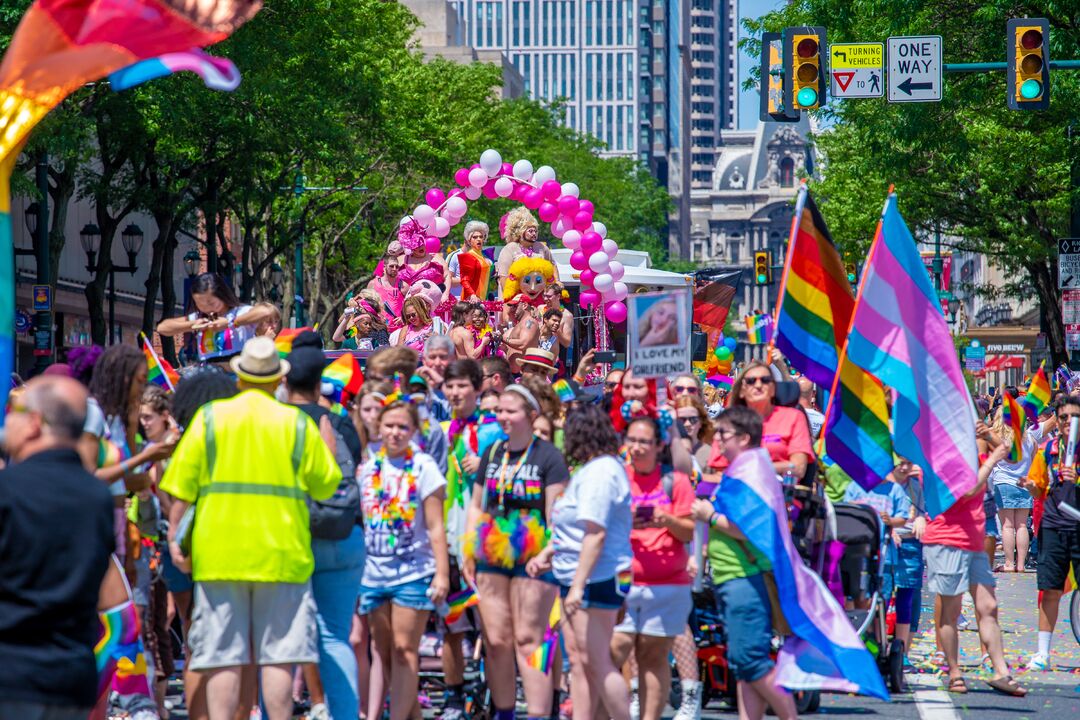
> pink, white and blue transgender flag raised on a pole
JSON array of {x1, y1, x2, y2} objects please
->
[{"x1": 848, "y1": 193, "x2": 978, "y2": 517}]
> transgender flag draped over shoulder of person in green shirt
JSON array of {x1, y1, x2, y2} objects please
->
[{"x1": 713, "y1": 451, "x2": 885, "y2": 699}]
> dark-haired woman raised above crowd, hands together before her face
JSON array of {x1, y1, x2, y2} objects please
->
[{"x1": 158, "y1": 272, "x2": 273, "y2": 362}]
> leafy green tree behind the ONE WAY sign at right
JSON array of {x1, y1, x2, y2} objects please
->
[{"x1": 746, "y1": 0, "x2": 1080, "y2": 364}]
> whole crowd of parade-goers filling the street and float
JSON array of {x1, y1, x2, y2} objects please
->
[{"x1": 0, "y1": 240, "x2": 1080, "y2": 720}]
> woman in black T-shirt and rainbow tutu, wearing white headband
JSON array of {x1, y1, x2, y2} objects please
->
[{"x1": 461, "y1": 384, "x2": 569, "y2": 720}]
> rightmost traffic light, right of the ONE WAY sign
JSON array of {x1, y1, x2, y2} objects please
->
[{"x1": 1005, "y1": 17, "x2": 1050, "y2": 110}]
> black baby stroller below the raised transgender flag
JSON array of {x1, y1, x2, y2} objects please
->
[{"x1": 834, "y1": 503, "x2": 904, "y2": 692}]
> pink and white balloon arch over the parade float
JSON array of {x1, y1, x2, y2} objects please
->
[{"x1": 401, "y1": 149, "x2": 629, "y2": 323}]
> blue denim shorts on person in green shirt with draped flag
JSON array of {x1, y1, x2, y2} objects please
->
[{"x1": 716, "y1": 574, "x2": 775, "y2": 682}]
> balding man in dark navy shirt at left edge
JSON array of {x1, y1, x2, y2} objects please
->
[{"x1": 0, "y1": 376, "x2": 114, "y2": 720}]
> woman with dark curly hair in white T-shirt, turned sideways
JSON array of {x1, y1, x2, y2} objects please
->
[{"x1": 528, "y1": 405, "x2": 633, "y2": 720}]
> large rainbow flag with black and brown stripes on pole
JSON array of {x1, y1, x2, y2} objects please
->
[{"x1": 774, "y1": 184, "x2": 893, "y2": 489}]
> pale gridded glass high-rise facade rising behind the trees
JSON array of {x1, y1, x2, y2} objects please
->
[{"x1": 451, "y1": 0, "x2": 638, "y2": 155}]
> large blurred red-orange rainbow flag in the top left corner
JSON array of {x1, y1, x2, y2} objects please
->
[{"x1": 0, "y1": 0, "x2": 262, "y2": 423}]
